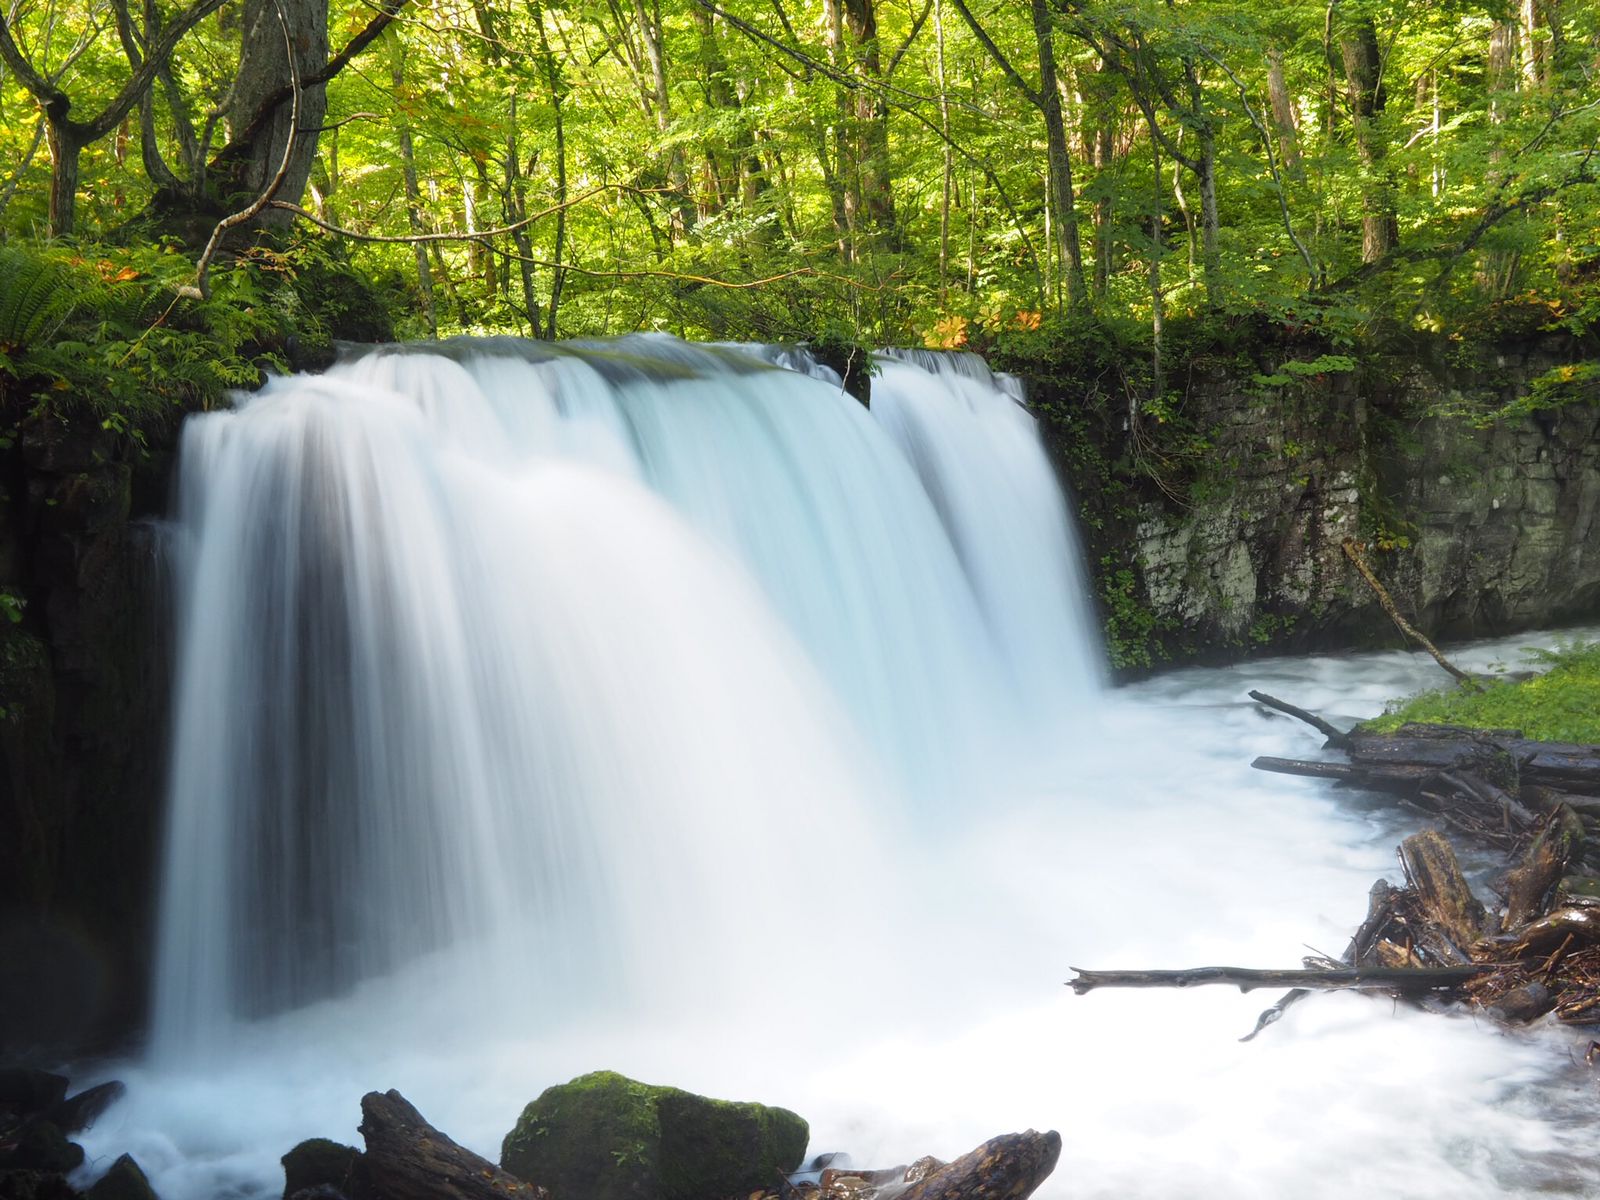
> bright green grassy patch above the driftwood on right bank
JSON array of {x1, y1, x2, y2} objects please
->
[{"x1": 1363, "y1": 642, "x2": 1600, "y2": 742}]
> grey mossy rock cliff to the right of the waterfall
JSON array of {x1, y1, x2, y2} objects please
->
[{"x1": 1078, "y1": 338, "x2": 1600, "y2": 667}]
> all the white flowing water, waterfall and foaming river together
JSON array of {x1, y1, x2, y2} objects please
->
[{"x1": 88, "y1": 339, "x2": 1600, "y2": 1200}]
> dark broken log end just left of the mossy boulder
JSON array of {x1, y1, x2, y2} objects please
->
[{"x1": 360, "y1": 1091, "x2": 550, "y2": 1200}]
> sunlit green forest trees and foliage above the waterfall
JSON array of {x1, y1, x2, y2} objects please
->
[{"x1": 0, "y1": 0, "x2": 1600, "y2": 350}]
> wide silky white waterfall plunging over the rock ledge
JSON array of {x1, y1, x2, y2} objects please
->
[{"x1": 155, "y1": 336, "x2": 1101, "y2": 1056}]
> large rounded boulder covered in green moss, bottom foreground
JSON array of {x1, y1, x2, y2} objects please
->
[{"x1": 501, "y1": 1070, "x2": 810, "y2": 1200}]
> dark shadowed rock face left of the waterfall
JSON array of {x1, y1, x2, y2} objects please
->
[{"x1": 0, "y1": 401, "x2": 176, "y2": 1053}]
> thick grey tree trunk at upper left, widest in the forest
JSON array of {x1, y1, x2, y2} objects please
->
[{"x1": 224, "y1": 0, "x2": 328, "y2": 226}]
